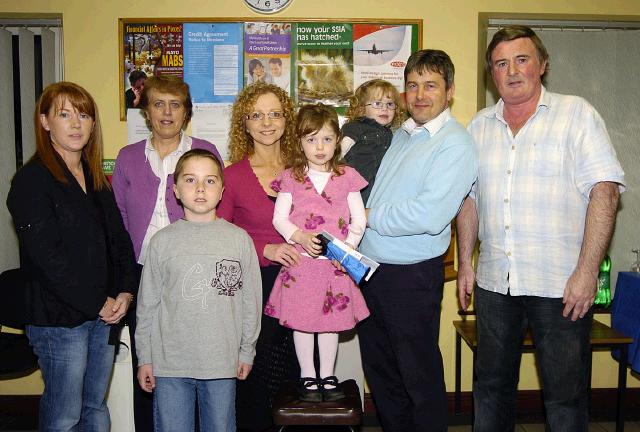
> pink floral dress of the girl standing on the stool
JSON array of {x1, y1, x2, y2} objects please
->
[{"x1": 264, "y1": 167, "x2": 369, "y2": 333}]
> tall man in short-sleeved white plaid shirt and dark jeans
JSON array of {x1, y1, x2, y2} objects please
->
[{"x1": 457, "y1": 26, "x2": 624, "y2": 432}]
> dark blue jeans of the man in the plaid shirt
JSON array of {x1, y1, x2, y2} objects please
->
[{"x1": 473, "y1": 288, "x2": 593, "y2": 432}]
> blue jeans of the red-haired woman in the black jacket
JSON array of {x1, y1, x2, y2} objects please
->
[{"x1": 26, "y1": 319, "x2": 114, "y2": 432}]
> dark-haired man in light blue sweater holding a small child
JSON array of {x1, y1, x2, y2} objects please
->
[{"x1": 358, "y1": 50, "x2": 477, "y2": 432}]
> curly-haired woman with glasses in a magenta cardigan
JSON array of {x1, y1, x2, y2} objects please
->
[{"x1": 217, "y1": 83, "x2": 300, "y2": 431}]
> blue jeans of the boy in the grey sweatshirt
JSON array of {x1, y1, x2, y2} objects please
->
[{"x1": 153, "y1": 377, "x2": 236, "y2": 432}]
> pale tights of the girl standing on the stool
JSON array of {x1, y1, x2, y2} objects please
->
[{"x1": 293, "y1": 331, "x2": 338, "y2": 388}]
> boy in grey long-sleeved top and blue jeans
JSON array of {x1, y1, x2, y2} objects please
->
[{"x1": 135, "y1": 150, "x2": 262, "y2": 431}]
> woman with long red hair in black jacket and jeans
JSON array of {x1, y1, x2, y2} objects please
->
[{"x1": 7, "y1": 82, "x2": 137, "y2": 432}]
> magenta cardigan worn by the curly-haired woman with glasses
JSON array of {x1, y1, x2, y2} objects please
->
[{"x1": 216, "y1": 157, "x2": 284, "y2": 267}]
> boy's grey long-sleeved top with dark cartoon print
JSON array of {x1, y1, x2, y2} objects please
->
[{"x1": 135, "y1": 219, "x2": 262, "y2": 379}]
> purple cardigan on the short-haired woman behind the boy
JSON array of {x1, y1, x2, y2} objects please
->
[{"x1": 111, "y1": 137, "x2": 224, "y2": 260}]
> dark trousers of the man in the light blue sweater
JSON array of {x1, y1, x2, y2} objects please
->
[{"x1": 358, "y1": 257, "x2": 447, "y2": 432}]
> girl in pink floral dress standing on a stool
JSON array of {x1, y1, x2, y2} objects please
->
[{"x1": 265, "y1": 104, "x2": 369, "y2": 402}]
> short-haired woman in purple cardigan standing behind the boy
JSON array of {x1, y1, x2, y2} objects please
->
[{"x1": 112, "y1": 75, "x2": 222, "y2": 432}]
